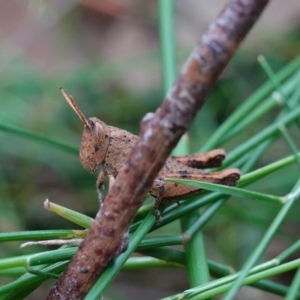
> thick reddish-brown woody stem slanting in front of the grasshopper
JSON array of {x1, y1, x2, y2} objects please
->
[{"x1": 48, "y1": 0, "x2": 268, "y2": 299}]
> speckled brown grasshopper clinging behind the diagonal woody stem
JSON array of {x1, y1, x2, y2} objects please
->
[{"x1": 61, "y1": 89, "x2": 240, "y2": 221}]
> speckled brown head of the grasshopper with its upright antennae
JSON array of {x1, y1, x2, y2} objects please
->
[{"x1": 61, "y1": 89, "x2": 109, "y2": 172}]
